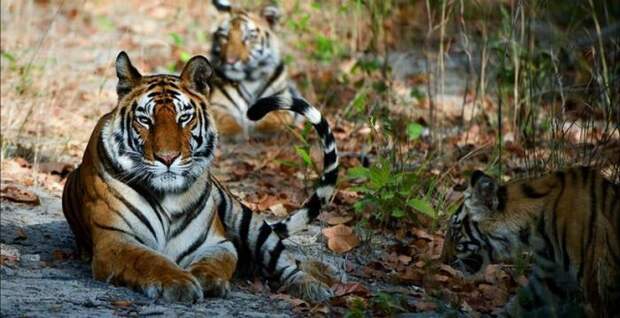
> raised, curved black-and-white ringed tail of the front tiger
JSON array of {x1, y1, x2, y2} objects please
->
[{"x1": 247, "y1": 96, "x2": 338, "y2": 238}]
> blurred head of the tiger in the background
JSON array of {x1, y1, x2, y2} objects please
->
[{"x1": 211, "y1": 1, "x2": 281, "y2": 81}]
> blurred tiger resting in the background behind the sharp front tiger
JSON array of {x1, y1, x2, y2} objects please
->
[{"x1": 210, "y1": 0, "x2": 300, "y2": 139}]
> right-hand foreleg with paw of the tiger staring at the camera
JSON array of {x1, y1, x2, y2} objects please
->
[{"x1": 188, "y1": 217, "x2": 237, "y2": 297}]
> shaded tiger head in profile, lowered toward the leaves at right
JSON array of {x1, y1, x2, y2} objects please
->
[{"x1": 441, "y1": 171, "x2": 528, "y2": 274}]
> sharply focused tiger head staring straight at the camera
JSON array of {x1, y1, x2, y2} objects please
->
[{"x1": 100, "y1": 52, "x2": 217, "y2": 193}]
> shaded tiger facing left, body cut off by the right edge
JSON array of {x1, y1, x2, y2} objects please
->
[{"x1": 441, "y1": 167, "x2": 620, "y2": 317}]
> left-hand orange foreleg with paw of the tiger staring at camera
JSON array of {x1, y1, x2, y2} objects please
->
[{"x1": 92, "y1": 231, "x2": 203, "y2": 303}]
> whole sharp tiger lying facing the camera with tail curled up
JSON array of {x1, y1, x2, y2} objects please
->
[{"x1": 62, "y1": 52, "x2": 339, "y2": 303}]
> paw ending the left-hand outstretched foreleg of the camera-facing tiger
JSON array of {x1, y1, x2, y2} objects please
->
[{"x1": 143, "y1": 271, "x2": 203, "y2": 303}]
